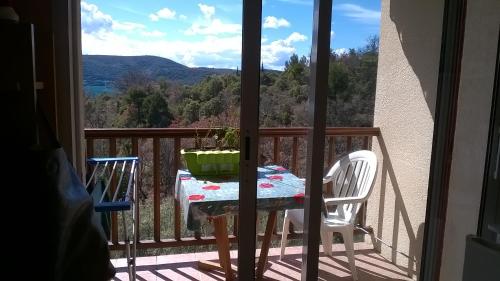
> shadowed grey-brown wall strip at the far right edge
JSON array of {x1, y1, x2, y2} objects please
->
[{"x1": 440, "y1": 0, "x2": 500, "y2": 281}]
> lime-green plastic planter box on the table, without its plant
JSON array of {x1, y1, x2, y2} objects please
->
[{"x1": 181, "y1": 149, "x2": 240, "y2": 176}]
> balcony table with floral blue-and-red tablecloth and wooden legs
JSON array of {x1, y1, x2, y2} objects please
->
[{"x1": 175, "y1": 165, "x2": 304, "y2": 280}]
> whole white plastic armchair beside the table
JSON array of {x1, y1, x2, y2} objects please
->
[{"x1": 280, "y1": 150, "x2": 377, "y2": 280}]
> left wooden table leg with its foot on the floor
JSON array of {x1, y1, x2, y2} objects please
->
[{"x1": 198, "y1": 216, "x2": 234, "y2": 280}]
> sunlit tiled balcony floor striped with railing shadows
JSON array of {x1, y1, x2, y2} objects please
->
[{"x1": 112, "y1": 243, "x2": 412, "y2": 281}]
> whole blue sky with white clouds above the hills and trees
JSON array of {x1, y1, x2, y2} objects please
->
[{"x1": 81, "y1": 0, "x2": 380, "y2": 69}]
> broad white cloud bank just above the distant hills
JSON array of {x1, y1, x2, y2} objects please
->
[{"x1": 82, "y1": 2, "x2": 307, "y2": 69}]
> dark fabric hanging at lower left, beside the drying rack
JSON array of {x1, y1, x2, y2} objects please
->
[{"x1": 29, "y1": 109, "x2": 115, "y2": 281}]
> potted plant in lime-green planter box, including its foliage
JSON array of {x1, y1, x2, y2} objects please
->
[{"x1": 181, "y1": 127, "x2": 240, "y2": 176}]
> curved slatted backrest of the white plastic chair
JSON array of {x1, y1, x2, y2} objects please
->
[{"x1": 325, "y1": 150, "x2": 377, "y2": 223}]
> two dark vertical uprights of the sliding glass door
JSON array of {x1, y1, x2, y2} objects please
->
[{"x1": 238, "y1": 0, "x2": 332, "y2": 280}]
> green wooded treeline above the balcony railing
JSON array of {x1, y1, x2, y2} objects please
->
[{"x1": 85, "y1": 36, "x2": 378, "y2": 128}]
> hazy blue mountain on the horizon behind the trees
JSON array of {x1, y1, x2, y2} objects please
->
[{"x1": 83, "y1": 55, "x2": 235, "y2": 94}]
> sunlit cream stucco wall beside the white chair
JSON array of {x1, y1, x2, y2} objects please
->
[{"x1": 367, "y1": 0, "x2": 444, "y2": 278}]
